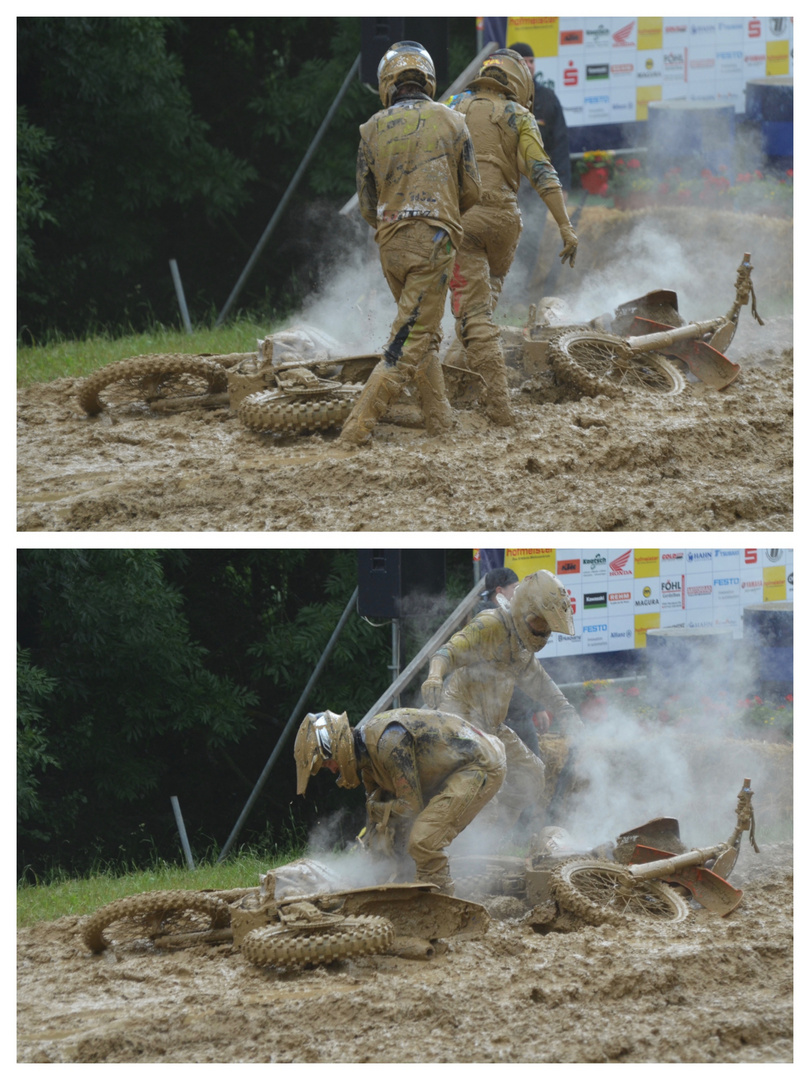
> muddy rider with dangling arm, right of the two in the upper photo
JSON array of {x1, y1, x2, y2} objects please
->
[{"x1": 447, "y1": 49, "x2": 578, "y2": 424}]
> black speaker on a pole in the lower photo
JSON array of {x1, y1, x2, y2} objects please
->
[{"x1": 357, "y1": 548, "x2": 445, "y2": 619}]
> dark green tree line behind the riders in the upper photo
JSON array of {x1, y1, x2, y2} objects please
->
[{"x1": 17, "y1": 16, "x2": 475, "y2": 339}]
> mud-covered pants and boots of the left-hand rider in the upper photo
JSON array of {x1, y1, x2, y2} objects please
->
[{"x1": 340, "y1": 218, "x2": 456, "y2": 445}]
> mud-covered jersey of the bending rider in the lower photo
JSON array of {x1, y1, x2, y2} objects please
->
[{"x1": 354, "y1": 708, "x2": 505, "y2": 819}]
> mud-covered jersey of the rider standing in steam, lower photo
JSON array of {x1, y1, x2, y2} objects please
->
[{"x1": 430, "y1": 607, "x2": 580, "y2": 734}]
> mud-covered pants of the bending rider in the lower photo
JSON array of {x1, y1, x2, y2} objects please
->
[{"x1": 407, "y1": 751, "x2": 507, "y2": 891}]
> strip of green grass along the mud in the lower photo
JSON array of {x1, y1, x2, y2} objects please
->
[{"x1": 17, "y1": 849, "x2": 302, "y2": 927}]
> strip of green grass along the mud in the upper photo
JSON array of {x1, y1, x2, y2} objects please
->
[{"x1": 17, "y1": 318, "x2": 272, "y2": 387}]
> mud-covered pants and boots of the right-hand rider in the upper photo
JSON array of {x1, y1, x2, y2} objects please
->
[{"x1": 448, "y1": 195, "x2": 522, "y2": 423}]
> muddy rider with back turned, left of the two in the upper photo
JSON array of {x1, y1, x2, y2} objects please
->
[{"x1": 339, "y1": 41, "x2": 481, "y2": 446}]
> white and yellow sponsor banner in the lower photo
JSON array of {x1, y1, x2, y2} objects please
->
[{"x1": 473, "y1": 548, "x2": 793, "y2": 657}]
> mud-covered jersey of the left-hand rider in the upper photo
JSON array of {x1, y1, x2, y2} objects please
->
[{"x1": 356, "y1": 97, "x2": 481, "y2": 247}]
